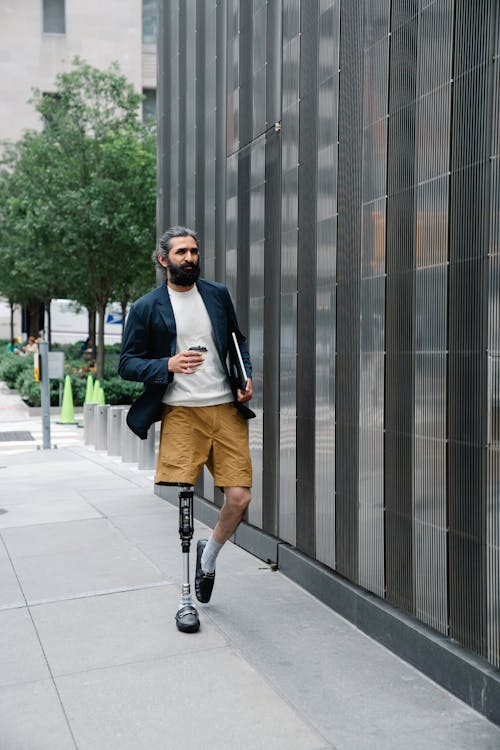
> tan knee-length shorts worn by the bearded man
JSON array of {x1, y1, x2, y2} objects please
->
[{"x1": 155, "y1": 403, "x2": 252, "y2": 487}]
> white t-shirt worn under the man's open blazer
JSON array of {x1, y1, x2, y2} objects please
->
[{"x1": 163, "y1": 285, "x2": 234, "y2": 406}]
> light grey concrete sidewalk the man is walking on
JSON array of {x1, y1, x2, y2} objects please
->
[{"x1": 0, "y1": 415, "x2": 500, "y2": 750}]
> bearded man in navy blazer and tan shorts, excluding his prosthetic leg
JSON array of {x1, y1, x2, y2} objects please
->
[{"x1": 118, "y1": 227, "x2": 255, "y2": 629}]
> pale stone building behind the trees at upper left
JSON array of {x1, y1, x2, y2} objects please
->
[{"x1": 0, "y1": 0, "x2": 157, "y2": 338}]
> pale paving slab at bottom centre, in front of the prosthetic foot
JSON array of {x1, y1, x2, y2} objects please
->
[{"x1": 56, "y1": 648, "x2": 328, "y2": 750}]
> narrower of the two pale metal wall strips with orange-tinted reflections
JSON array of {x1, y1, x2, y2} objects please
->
[{"x1": 358, "y1": 0, "x2": 390, "y2": 596}]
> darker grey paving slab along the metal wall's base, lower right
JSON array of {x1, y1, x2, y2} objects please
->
[{"x1": 207, "y1": 568, "x2": 500, "y2": 750}]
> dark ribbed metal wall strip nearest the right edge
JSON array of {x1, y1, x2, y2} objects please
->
[{"x1": 448, "y1": 0, "x2": 498, "y2": 656}]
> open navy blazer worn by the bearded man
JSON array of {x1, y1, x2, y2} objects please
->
[{"x1": 118, "y1": 279, "x2": 255, "y2": 440}]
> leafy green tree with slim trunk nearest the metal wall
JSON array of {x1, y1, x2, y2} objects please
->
[{"x1": 33, "y1": 58, "x2": 156, "y2": 378}]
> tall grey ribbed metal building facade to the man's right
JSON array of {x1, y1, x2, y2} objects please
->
[{"x1": 158, "y1": 0, "x2": 500, "y2": 666}]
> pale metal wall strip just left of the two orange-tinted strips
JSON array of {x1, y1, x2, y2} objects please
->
[{"x1": 315, "y1": 0, "x2": 340, "y2": 568}]
